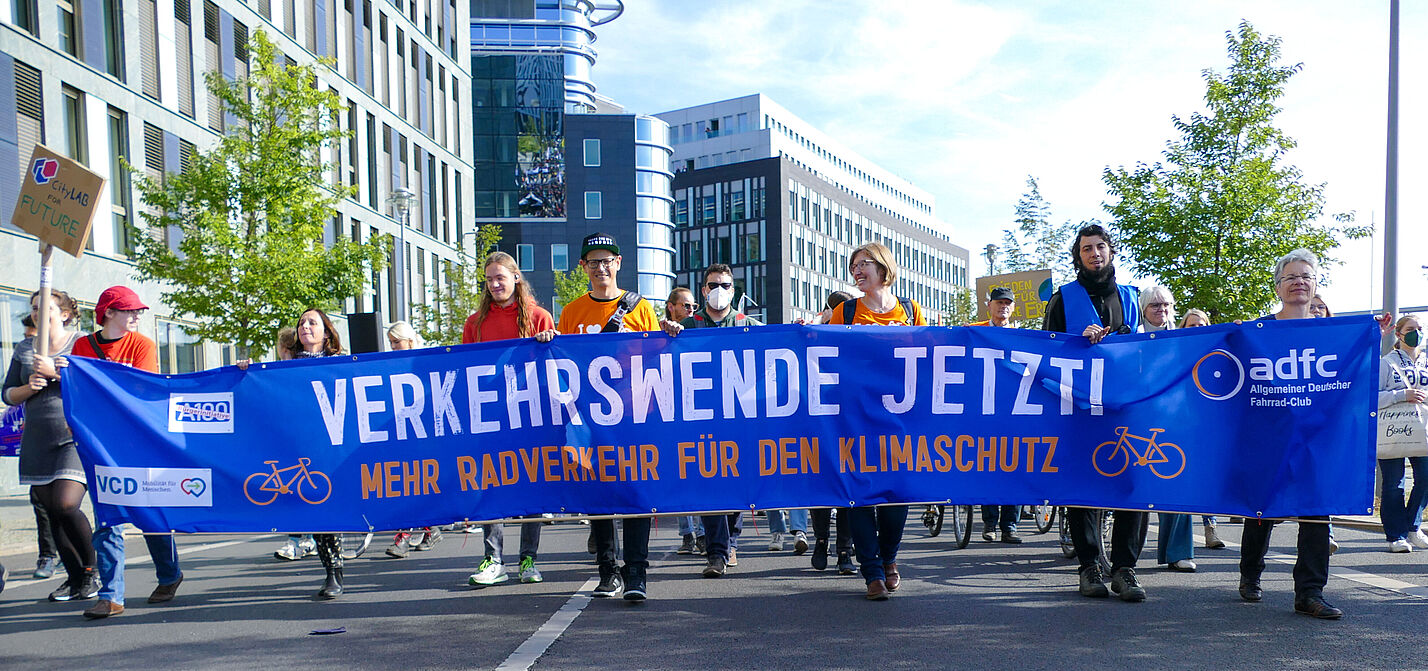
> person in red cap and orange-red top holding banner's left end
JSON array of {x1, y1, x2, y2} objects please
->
[{"x1": 71, "y1": 287, "x2": 183, "y2": 620}]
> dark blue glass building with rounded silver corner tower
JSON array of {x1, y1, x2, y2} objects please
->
[{"x1": 471, "y1": 0, "x2": 674, "y2": 308}]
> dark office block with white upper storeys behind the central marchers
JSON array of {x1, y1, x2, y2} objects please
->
[{"x1": 657, "y1": 94, "x2": 968, "y2": 323}]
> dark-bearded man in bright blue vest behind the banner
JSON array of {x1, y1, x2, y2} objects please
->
[{"x1": 1044, "y1": 224, "x2": 1148, "y2": 601}]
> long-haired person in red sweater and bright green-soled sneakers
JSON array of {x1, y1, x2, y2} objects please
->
[{"x1": 461, "y1": 251, "x2": 555, "y2": 587}]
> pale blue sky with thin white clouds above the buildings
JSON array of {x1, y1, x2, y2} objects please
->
[{"x1": 593, "y1": 0, "x2": 1428, "y2": 311}]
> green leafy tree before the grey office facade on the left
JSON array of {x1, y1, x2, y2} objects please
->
[{"x1": 127, "y1": 30, "x2": 387, "y2": 357}]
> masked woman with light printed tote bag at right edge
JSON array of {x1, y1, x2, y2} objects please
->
[{"x1": 1378, "y1": 314, "x2": 1428, "y2": 553}]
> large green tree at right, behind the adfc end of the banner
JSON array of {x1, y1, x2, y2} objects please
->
[{"x1": 1102, "y1": 21, "x2": 1368, "y2": 321}]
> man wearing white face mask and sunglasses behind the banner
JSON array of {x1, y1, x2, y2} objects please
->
[{"x1": 660, "y1": 263, "x2": 771, "y2": 578}]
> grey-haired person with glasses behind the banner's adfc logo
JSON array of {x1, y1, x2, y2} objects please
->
[{"x1": 1240, "y1": 248, "x2": 1344, "y2": 620}]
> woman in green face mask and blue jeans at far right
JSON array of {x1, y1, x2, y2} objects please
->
[{"x1": 1378, "y1": 314, "x2": 1428, "y2": 553}]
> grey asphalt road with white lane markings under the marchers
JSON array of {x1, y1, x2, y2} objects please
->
[{"x1": 0, "y1": 518, "x2": 1428, "y2": 671}]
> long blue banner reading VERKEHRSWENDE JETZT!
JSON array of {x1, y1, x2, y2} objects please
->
[{"x1": 64, "y1": 317, "x2": 1378, "y2": 533}]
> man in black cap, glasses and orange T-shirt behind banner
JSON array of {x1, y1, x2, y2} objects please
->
[{"x1": 536, "y1": 233, "x2": 660, "y2": 601}]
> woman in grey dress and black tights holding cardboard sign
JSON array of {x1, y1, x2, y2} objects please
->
[{"x1": 0, "y1": 288, "x2": 100, "y2": 601}]
